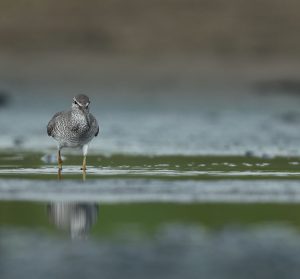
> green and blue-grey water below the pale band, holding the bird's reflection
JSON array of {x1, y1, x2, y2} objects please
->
[{"x1": 0, "y1": 201, "x2": 300, "y2": 278}]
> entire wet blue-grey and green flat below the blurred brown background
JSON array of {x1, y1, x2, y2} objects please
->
[{"x1": 0, "y1": 92, "x2": 300, "y2": 279}]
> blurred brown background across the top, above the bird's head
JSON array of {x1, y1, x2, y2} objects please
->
[{"x1": 0, "y1": 0, "x2": 300, "y2": 93}]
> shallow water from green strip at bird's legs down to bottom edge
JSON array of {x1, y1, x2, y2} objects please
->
[{"x1": 0, "y1": 150, "x2": 300, "y2": 279}]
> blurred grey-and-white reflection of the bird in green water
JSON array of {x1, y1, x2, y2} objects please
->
[{"x1": 47, "y1": 202, "x2": 99, "y2": 239}]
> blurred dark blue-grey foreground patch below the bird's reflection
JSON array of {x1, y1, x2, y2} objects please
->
[{"x1": 0, "y1": 224, "x2": 300, "y2": 279}]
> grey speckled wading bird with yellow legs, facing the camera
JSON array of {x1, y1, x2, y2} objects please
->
[{"x1": 47, "y1": 94, "x2": 99, "y2": 171}]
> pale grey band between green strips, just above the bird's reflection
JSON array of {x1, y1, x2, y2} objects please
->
[{"x1": 0, "y1": 178, "x2": 300, "y2": 203}]
